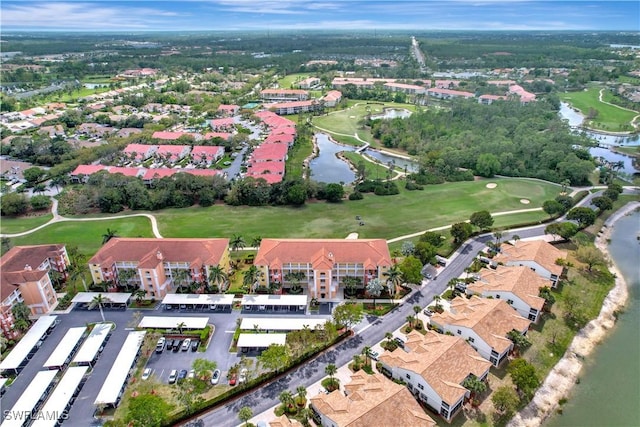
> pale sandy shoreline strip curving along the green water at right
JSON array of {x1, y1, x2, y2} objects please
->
[{"x1": 507, "y1": 202, "x2": 640, "y2": 427}]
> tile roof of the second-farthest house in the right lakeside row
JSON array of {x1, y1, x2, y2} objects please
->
[{"x1": 467, "y1": 266, "x2": 549, "y2": 311}]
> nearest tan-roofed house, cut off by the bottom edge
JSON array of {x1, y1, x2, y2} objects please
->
[{"x1": 309, "y1": 370, "x2": 436, "y2": 427}]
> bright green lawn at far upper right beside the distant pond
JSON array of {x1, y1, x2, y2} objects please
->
[{"x1": 559, "y1": 86, "x2": 638, "y2": 132}]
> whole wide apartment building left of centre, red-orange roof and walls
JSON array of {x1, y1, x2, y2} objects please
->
[{"x1": 89, "y1": 237, "x2": 229, "y2": 299}]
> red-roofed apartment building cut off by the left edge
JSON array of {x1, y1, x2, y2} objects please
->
[{"x1": 0, "y1": 245, "x2": 69, "y2": 339}]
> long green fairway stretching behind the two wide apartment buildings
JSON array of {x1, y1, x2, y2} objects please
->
[{"x1": 155, "y1": 179, "x2": 559, "y2": 239}]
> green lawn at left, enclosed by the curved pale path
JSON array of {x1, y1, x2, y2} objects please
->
[{"x1": 10, "y1": 217, "x2": 153, "y2": 255}]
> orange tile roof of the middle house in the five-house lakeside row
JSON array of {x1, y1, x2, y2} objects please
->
[{"x1": 431, "y1": 296, "x2": 531, "y2": 353}]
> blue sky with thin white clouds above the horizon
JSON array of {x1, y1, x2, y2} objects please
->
[{"x1": 0, "y1": 0, "x2": 640, "y2": 32}]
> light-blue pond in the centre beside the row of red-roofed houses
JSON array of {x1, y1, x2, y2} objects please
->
[{"x1": 309, "y1": 133, "x2": 356, "y2": 183}]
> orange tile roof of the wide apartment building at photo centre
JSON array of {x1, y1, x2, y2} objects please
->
[{"x1": 255, "y1": 239, "x2": 391, "y2": 268}]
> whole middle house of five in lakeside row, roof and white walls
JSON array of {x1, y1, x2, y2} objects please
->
[{"x1": 431, "y1": 296, "x2": 531, "y2": 367}]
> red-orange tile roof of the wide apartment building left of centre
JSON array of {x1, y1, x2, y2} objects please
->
[{"x1": 89, "y1": 237, "x2": 229, "y2": 265}]
